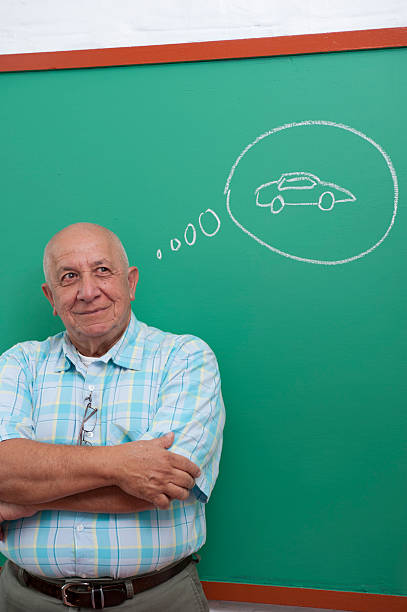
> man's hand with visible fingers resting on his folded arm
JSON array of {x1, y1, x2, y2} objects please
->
[{"x1": 110, "y1": 432, "x2": 201, "y2": 510}]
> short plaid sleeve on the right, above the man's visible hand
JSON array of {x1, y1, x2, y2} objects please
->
[{"x1": 141, "y1": 336, "x2": 225, "y2": 503}]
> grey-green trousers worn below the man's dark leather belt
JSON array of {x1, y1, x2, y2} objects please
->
[{"x1": 0, "y1": 562, "x2": 209, "y2": 612}]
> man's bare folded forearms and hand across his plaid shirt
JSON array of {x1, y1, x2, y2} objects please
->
[{"x1": 0, "y1": 433, "x2": 200, "y2": 522}]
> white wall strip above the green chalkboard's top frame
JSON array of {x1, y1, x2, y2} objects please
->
[{"x1": 0, "y1": 0, "x2": 407, "y2": 54}]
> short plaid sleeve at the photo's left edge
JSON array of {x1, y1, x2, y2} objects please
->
[{"x1": 0, "y1": 347, "x2": 34, "y2": 442}]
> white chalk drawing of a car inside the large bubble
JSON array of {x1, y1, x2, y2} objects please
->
[{"x1": 254, "y1": 172, "x2": 356, "y2": 215}]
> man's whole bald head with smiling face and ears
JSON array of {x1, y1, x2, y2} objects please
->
[{"x1": 43, "y1": 230, "x2": 138, "y2": 352}]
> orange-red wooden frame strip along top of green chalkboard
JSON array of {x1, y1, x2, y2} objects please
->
[{"x1": 0, "y1": 27, "x2": 407, "y2": 72}]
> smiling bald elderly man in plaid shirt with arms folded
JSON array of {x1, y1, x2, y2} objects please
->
[{"x1": 0, "y1": 223, "x2": 224, "y2": 612}]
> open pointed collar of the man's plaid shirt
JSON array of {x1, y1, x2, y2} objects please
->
[{"x1": 56, "y1": 312, "x2": 144, "y2": 372}]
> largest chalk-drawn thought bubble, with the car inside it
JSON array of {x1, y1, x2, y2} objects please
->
[{"x1": 224, "y1": 120, "x2": 398, "y2": 265}]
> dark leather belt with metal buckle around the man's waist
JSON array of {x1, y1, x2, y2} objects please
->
[{"x1": 15, "y1": 555, "x2": 193, "y2": 610}]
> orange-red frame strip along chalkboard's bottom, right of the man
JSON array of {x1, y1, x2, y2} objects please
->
[{"x1": 202, "y1": 581, "x2": 407, "y2": 612}]
